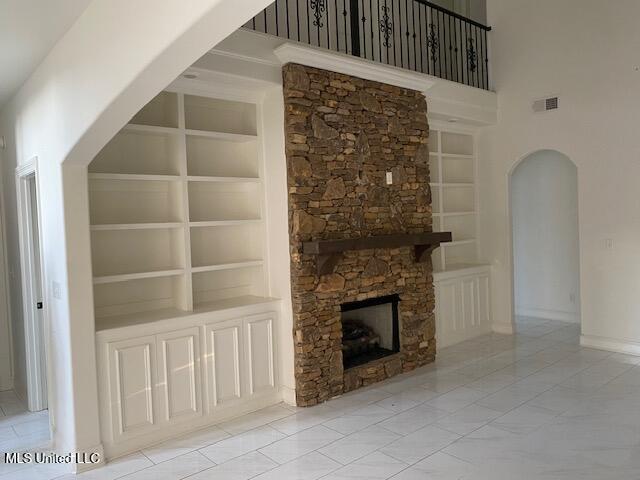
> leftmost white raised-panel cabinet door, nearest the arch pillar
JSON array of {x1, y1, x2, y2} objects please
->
[{"x1": 108, "y1": 336, "x2": 157, "y2": 442}]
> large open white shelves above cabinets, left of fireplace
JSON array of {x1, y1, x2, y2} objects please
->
[{"x1": 89, "y1": 91, "x2": 268, "y2": 331}]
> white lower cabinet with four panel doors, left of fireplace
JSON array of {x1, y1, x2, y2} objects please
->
[{"x1": 97, "y1": 306, "x2": 279, "y2": 456}]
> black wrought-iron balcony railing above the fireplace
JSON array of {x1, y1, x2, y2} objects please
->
[{"x1": 244, "y1": 0, "x2": 491, "y2": 90}]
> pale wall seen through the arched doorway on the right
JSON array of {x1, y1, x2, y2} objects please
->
[{"x1": 511, "y1": 150, "x2": 580, "y2": 322}]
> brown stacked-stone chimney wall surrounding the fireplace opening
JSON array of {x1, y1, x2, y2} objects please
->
[{"x1": 283, "y1": 64, "x2": 435, "y2": 406}]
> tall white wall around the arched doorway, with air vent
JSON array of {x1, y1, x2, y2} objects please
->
[{"x1": 479, "y1": 0, "x2": 640, "y2": 342}]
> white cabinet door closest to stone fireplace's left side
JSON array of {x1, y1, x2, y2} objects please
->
[{"x1": 244, "y1": 313, "x2": 276, "y2": 395}]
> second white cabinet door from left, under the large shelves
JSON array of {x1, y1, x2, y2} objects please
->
[{"x1": 156, "y1": 327, "x2": 202, "y2": 423}]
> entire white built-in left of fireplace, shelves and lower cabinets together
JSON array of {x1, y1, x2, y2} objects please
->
[{"x1": 88, "y1": 91, "x2": 280, "y2": 457}]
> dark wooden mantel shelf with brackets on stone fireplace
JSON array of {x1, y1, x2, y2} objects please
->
[{"x1": 302, "y1": 232, "x2": 451, "y2": 275}]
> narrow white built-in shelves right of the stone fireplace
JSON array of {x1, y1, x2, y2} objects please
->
[{"x1": 429, "y1": 128, "x2": 478, "y2": 272}]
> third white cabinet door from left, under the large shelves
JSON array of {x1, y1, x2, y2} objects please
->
[{"x1": 205, "y1": 318, "x2": 243, "y2": 411}]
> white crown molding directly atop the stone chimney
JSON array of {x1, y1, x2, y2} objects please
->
[{"x1": 273, "y1": 43, "x2": 436, "y2": 93}]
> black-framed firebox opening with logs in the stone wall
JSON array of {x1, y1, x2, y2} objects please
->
[{"x1": 340, "y1": 295, "x2": 400, "y2": 370}]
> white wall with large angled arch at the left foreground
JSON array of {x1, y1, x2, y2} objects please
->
[{"x1": 0, "y1": 0, "x2": 270, "y2": 468}]
